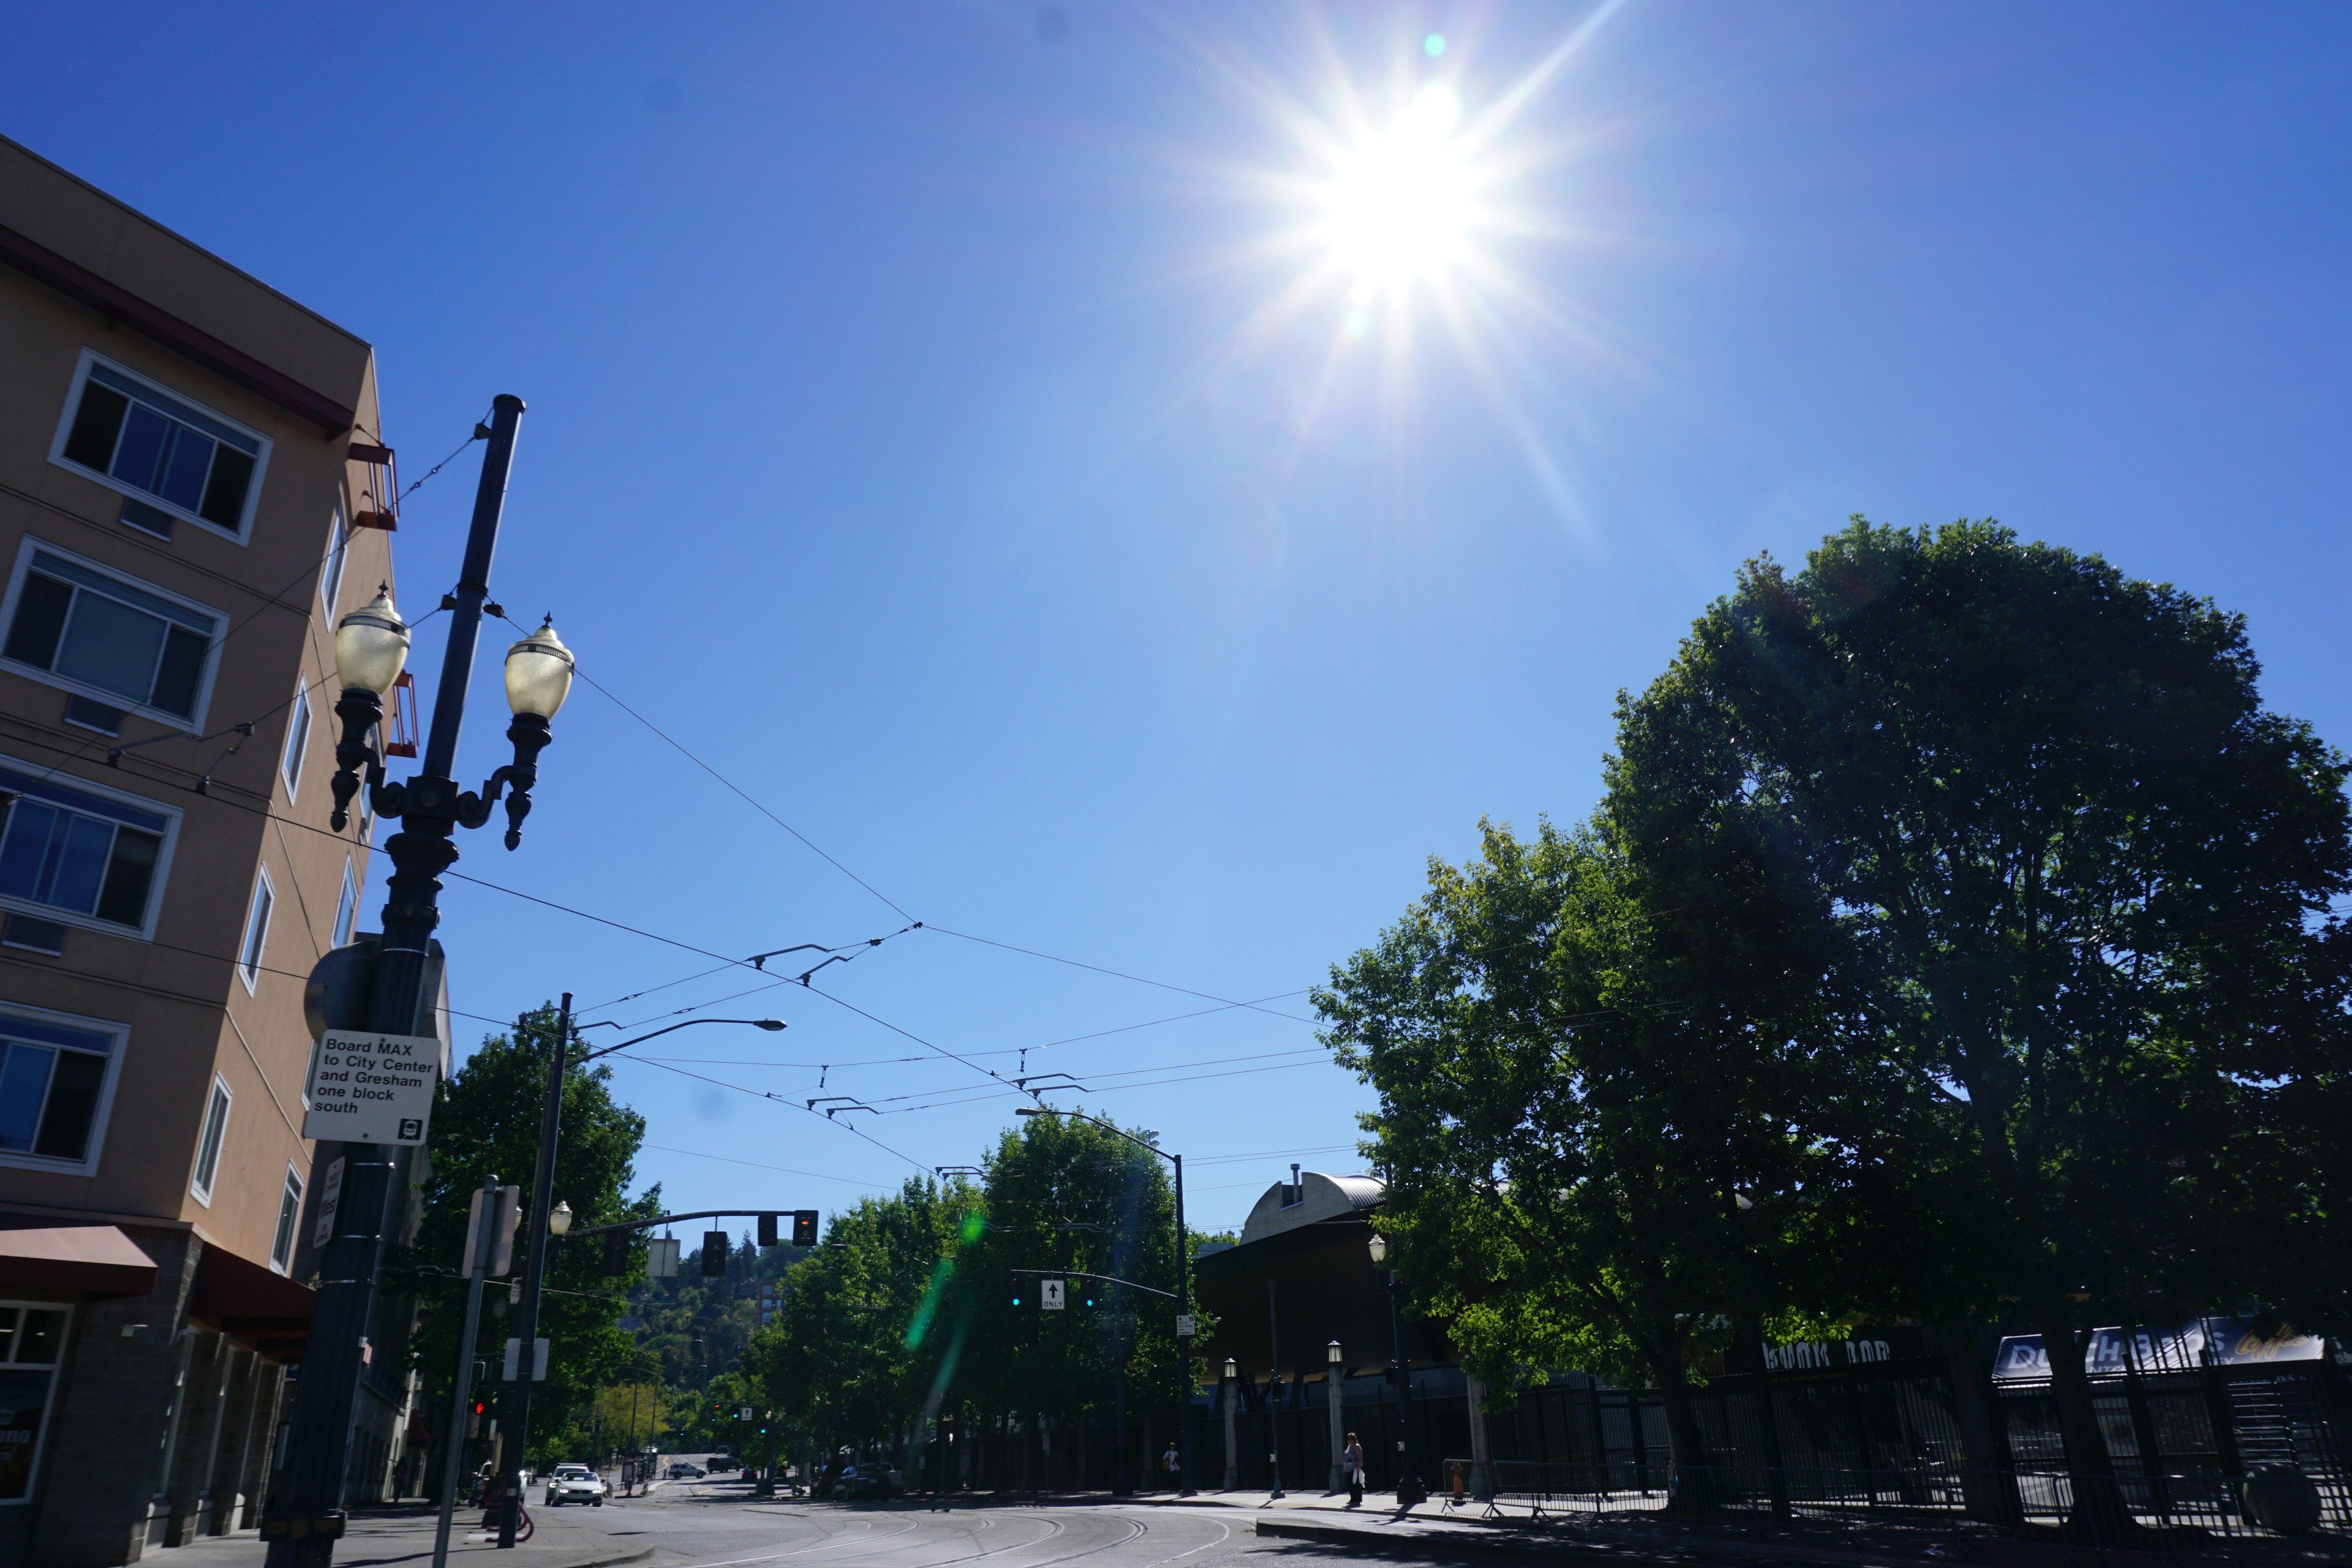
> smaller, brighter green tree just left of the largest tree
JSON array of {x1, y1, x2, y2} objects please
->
[{"x1": 1315, "y1": 820, "x2": 1844, "y2": 1507}]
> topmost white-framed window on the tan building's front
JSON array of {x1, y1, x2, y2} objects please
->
[{"x1": 50, "y1": 348, "x2": 271, "y2": 541}]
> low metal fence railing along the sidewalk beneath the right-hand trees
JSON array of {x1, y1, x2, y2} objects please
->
[{"x1": 1439, "y1": 1460, "x2": 2352, "y2": 1549}]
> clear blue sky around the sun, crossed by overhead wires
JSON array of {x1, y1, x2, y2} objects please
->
[{"x1": 0, "y1": 0, "x2": 2352, "y2": 1225}]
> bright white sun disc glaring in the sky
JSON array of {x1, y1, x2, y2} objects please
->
[{"x1": 1322, "y1": 82, "x2": 1477, "y2": 292}]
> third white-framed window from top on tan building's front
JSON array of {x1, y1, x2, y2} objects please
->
[{"x1": 0, "y1": 762, "x2": 179, "y2": 936}]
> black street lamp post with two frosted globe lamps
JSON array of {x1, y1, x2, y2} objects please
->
[{"x1": 261, "y1": 393, "x2": 571, "y2": 1568}]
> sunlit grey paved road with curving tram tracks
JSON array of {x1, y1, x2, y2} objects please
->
[{"x1": 562, "y1": 1481, "x2": 1437, "y2": 1568}]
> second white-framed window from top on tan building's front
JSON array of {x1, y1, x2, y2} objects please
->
[{"x1": 0, "y1": 538, "x2": 224, "y2": 729}]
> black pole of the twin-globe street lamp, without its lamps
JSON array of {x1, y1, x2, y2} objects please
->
[{"x1": 263, "y1": 393, "x2": 522, "y2": 1568}]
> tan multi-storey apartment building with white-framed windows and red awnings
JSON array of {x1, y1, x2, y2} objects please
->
[{"x1": 0, "y1": 138, "x2": 428, "y2": 1568}]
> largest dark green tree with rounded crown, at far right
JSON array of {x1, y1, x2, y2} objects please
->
[{"x1": 1609, "y1": 519, "x2": 2352, "y2": 1514}]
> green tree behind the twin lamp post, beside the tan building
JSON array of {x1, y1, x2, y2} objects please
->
[{"x1": 386, "y1": 1006, "x2": 661, "y2": 1462}]
